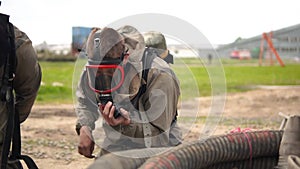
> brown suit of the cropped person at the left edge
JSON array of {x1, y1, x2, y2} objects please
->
[{"x1": 0, "y1": 26, "x2": 42, "y2": 168}]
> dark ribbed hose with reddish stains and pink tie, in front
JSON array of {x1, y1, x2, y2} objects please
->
[{"x1": 140, "y1": 131, "x2": 283, "y2": 169}]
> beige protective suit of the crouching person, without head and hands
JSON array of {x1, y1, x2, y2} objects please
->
[{"x1": 76, "y1": 26, "x2": 182, "y2": 156}]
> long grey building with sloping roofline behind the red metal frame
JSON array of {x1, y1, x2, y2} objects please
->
[{"x1": 217, "y1": 24, "x2": 300, "y2": 58}]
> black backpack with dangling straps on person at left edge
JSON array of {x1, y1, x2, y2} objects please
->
[{"x1": 0, "y1": 13, "x2": 38, "y2": 169}]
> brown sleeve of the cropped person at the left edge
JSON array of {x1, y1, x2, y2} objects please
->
[{"x1": 14, "y1": 39, "x2": 42, "y2": 122}]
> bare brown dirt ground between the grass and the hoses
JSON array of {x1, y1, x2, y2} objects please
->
[{"x1": 21, "y1": 86, "x2": 300, "y2": 169}]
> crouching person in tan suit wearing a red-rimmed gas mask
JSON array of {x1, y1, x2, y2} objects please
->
[{"x1": 75, "y1": 25, "x2": 182, "y2": 158}]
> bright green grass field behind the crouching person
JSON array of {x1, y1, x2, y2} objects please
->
[{"x1": 36, "y1": 59, "x2": 300, "y2": 104}]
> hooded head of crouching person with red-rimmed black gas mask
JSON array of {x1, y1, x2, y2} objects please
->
[{"x1": 86, "y1": 27, "x2": 143, "y2": 118}]
